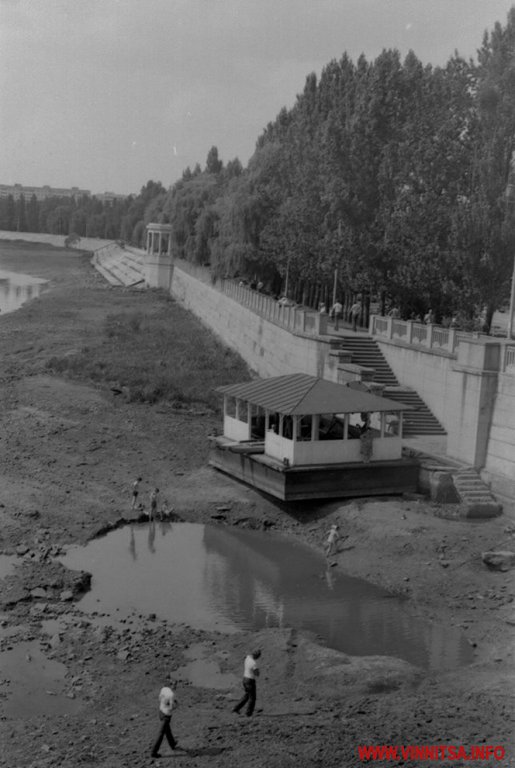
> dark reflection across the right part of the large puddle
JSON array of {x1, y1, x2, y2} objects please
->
[{"x1": 203, "y1": 525, "x2": 471, "y2": 669}]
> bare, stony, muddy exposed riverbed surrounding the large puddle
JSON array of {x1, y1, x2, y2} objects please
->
[{"x1": 0, "y1": 246, "x2": 515, "y2": 768}]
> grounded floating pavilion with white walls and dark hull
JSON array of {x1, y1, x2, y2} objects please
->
[{"x1": 210, "y1": 373, "x2": 418, "y2": 501}]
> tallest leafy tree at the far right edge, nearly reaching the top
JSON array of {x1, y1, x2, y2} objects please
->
[{"x1": 453, "y1": 8, "x2": 515, "y2": 329}]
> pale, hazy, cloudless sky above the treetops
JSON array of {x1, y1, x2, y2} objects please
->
[{"x1": 0, "y1": 0, "x2": 514, "y2": 194}]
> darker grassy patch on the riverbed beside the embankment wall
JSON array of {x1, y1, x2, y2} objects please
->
[{"x1": 47, "y1": 300, "x2": 249, "y2": 410}]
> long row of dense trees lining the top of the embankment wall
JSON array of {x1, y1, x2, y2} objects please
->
[{"x1": 0, "y1": 8, "x2": 515, "y2": 324}]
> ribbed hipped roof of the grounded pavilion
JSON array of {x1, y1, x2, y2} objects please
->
[{"x1": 216, "y1": 373, "x2": 411, "y2": 416}]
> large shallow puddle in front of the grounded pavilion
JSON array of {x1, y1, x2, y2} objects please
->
[{"x1": 61, "y1": 522, "x2": 473, "y2": 669}]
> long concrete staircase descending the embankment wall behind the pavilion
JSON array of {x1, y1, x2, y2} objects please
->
[{"x1": 341, "y1": 336, "x2": 446, "y2": 437}]
